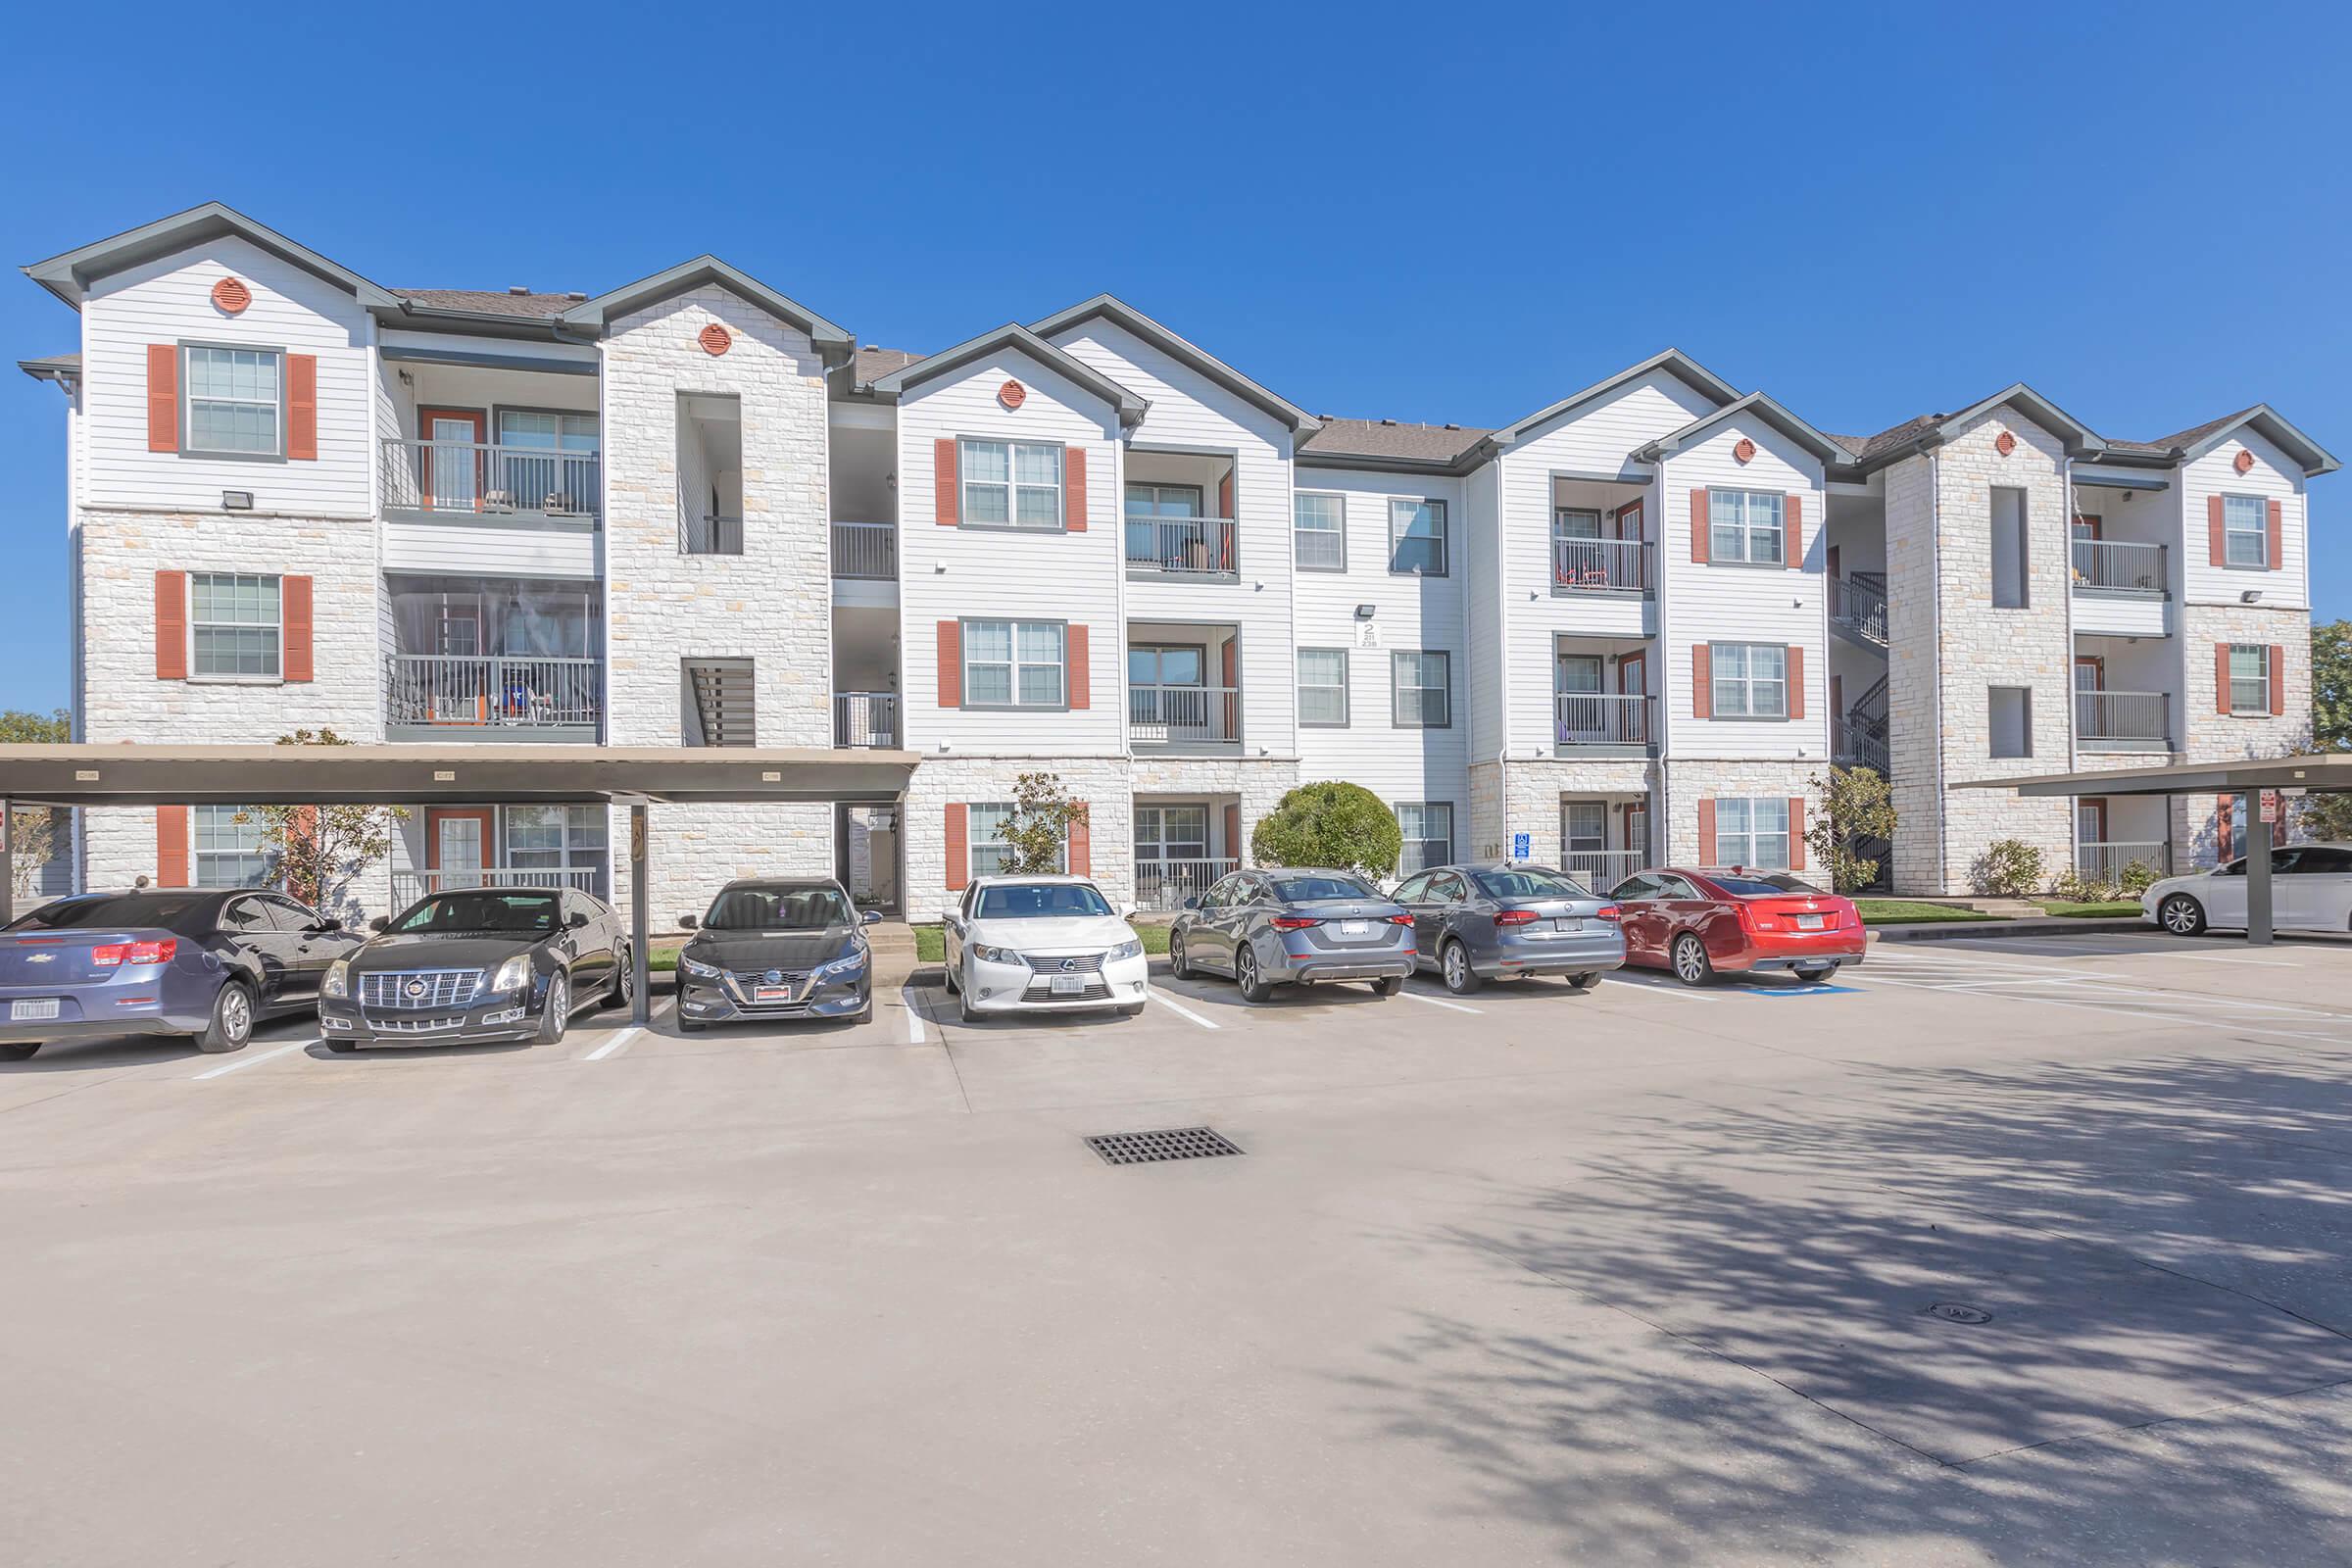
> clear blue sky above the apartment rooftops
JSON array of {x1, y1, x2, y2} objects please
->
[{"x1": 0, "y1": 0, "x2": 2352, "y2": 706}]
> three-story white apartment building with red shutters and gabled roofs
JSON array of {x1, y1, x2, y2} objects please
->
[{"x1": 24, "y1": 205, "x2": 2335, "y2": 919}]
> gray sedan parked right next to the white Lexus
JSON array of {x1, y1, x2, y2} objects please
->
[{"x1": 1169, "y1": 867, "x2": 1413, "y2": 1002}]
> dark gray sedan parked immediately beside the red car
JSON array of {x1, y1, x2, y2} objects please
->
[{"x1": 1397, "y1": 860, "x2": 1625, "y2": 997}]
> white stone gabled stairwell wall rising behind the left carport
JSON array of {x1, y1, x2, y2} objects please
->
[{"x1": 605, "y1": 284, "x2": 833, "y2": 926}]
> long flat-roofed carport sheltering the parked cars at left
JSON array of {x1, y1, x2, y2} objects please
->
[{"x1": 0, "y1": 745, "x2": 915, "y2": 1022}]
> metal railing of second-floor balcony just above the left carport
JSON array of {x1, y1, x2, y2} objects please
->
[{"x1": 383, "y1": 654, "x2": 605, "y2": 743}]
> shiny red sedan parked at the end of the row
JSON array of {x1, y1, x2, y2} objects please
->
[{"x1": 1609, "y1": 867, "x2": 1870, "y2": 985}]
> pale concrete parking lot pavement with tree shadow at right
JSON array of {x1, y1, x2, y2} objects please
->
[{"x1": 0, "y1": 936, "x2": 2352, "y2": 1566}]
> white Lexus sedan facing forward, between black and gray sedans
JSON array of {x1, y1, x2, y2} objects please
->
[{"x1": 948, "y1": 877, "x2": 1148, "y2": 1022}]
